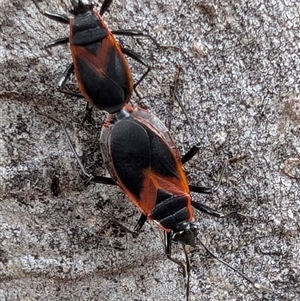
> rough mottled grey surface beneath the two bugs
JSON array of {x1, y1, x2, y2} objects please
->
[{"x1": 0, "y1": 0, "x2": 300, "y2": 301}]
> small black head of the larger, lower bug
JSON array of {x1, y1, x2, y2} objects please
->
[{"x1": 172, "y1": 222, "x2": 198, "y2": 247}]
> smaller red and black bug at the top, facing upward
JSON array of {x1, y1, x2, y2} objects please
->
[{"x1": 33, "y1": 0, "x2": 158, "y2": 113}]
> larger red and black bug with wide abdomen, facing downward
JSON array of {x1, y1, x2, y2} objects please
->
[{"x1": 51, "y1": 105, "x2": 251, "y2": 300}]
